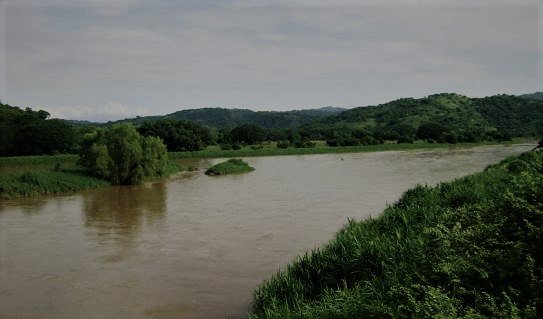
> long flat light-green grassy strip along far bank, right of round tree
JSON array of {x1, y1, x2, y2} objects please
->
[{"x1": 169, "y1": 139, "x2": 537, "y2": 159}]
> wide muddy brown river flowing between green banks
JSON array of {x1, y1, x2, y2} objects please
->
[{"x1": 0, "y1": 145, "x2": 531, "y2": 319}]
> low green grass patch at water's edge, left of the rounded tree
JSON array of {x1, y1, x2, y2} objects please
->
[{"x1": 0, "y1": 170, "x2": 109, "y2": 199}]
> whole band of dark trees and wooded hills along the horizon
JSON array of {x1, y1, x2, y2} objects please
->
[{"x1": 0, "y1": 93, "x2": 543, "y2": 156}]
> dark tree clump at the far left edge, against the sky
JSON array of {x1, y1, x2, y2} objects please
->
[{"x1": 0, "y1": 103, "x2": 75, "y2": 156}]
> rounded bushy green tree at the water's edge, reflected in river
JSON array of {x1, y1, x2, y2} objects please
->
[{"x1": 79, "y1": 124, "x2": 168, "y2": 184}]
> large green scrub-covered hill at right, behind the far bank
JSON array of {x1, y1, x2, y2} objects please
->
[{"x1": 302, "y1": 93, "x2": 543, "y2": 142}]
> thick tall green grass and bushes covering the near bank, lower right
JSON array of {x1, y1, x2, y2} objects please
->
[{"x1": 250, "y1": 151, "x2": 543, "y2": 319}]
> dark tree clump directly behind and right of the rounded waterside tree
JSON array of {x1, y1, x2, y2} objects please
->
[{"x1": 138, "y1": 120, "x2": 215, "y2": 152}]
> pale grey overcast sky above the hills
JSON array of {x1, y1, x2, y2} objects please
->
[{"x1": 0, "y1": 0, "x2": 543, "y2": 121}]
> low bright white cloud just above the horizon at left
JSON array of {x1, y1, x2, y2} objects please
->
[{"x1": 39, "y1": 101, "x2": 152, "y2": 122}]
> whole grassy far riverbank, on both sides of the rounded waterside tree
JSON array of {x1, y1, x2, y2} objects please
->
[{"x1": 0, "y1": 140, "x2": 537, "y2": 199}]
